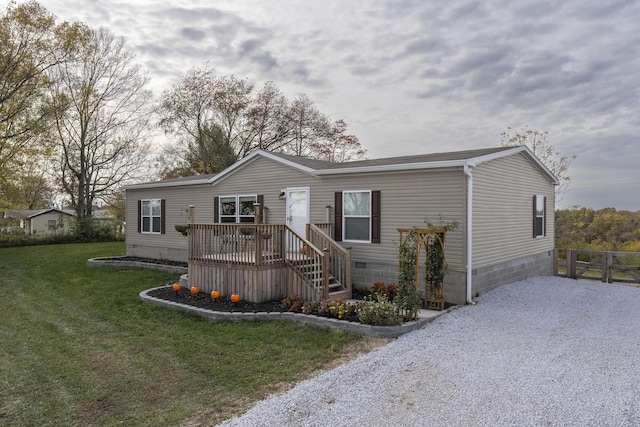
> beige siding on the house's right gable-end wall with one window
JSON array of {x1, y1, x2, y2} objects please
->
[{"x1": 473, "y1": 154, "x2": 555, "y2": 269}]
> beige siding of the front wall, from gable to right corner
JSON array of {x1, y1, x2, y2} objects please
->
[{"x1": 214, "y1": 157, "x2": 466, "y2": 269}]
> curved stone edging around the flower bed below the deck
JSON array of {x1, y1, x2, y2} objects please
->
[{"x1": 139, "y1": 286, "x2": 451, "y2": 338}]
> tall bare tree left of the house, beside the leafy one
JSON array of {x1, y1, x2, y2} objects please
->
[{"x1": 51, "y1": 27, "x2": 150, "y2": 220}]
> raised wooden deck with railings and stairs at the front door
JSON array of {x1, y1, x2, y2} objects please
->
[{"x1": 184, "y1": 224, "x2": 351, "y2": 302}]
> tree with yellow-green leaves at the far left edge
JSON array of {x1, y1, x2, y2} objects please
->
[{"x1": 0, "y1": 1, "x2": 63, "y2": 208}]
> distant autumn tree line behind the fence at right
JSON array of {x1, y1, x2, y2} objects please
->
[{"x1": 555, "y1": 207, "x2": 640, "y2": 252}]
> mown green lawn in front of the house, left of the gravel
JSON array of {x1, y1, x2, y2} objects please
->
[{"x1": 0, "y1": 242, "x2": 379, "y2": 426}]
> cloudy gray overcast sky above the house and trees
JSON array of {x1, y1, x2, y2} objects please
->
[{"x1": 27, "y1": 0, "x2": 640, "y2": 211}]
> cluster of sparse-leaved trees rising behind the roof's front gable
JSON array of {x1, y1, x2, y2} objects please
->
[{"x1": 158, "y1": 65, "x2": 364, "y2": 178}]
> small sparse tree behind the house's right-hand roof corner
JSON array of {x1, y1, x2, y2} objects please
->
[{"x1": 500, "y1": 126, "x2": 577, "y2": 201}]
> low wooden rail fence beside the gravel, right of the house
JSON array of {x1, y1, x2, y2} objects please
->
[{"x1": 554, "y1": 249, "x2": 640, "y2": 284}]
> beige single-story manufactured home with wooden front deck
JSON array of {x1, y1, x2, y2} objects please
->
[{"x1": 125, "y1": 146, "x2": 558, "y2": 304}]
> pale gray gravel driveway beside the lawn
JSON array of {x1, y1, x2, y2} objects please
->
[{"x1": 223, "y1": 277, "x2": 640, "y2": 426}]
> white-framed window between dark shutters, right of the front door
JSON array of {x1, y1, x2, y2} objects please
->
[{"x1": 342, "y1": 191, "x2": 371, "y2": 242}]
